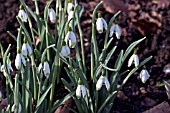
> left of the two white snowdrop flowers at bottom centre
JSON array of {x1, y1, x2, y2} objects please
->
[{"x1": 76, "y1": 79, "x2": 86, "y2": 99}]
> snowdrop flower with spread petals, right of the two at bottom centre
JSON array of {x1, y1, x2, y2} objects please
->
[{"x1": 96, "y1": 76, "x2": 110, "y2": 91}]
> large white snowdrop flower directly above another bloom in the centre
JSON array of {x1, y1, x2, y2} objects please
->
[{"x1": 65, "y1": 27, "x2": 76, "y2": 48}]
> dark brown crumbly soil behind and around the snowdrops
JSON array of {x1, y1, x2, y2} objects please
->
[{"x1": 0, "y1": 0, "x2": 170, "y2": 113}]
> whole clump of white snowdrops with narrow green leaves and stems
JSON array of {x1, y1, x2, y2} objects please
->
[{"x1": 0, "y1": 0, "x2": 152, "y2": 113}]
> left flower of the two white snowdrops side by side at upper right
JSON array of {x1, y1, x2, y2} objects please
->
[{"x1": 96, "y1": 13, "x2": 107, "y2": 33}]
